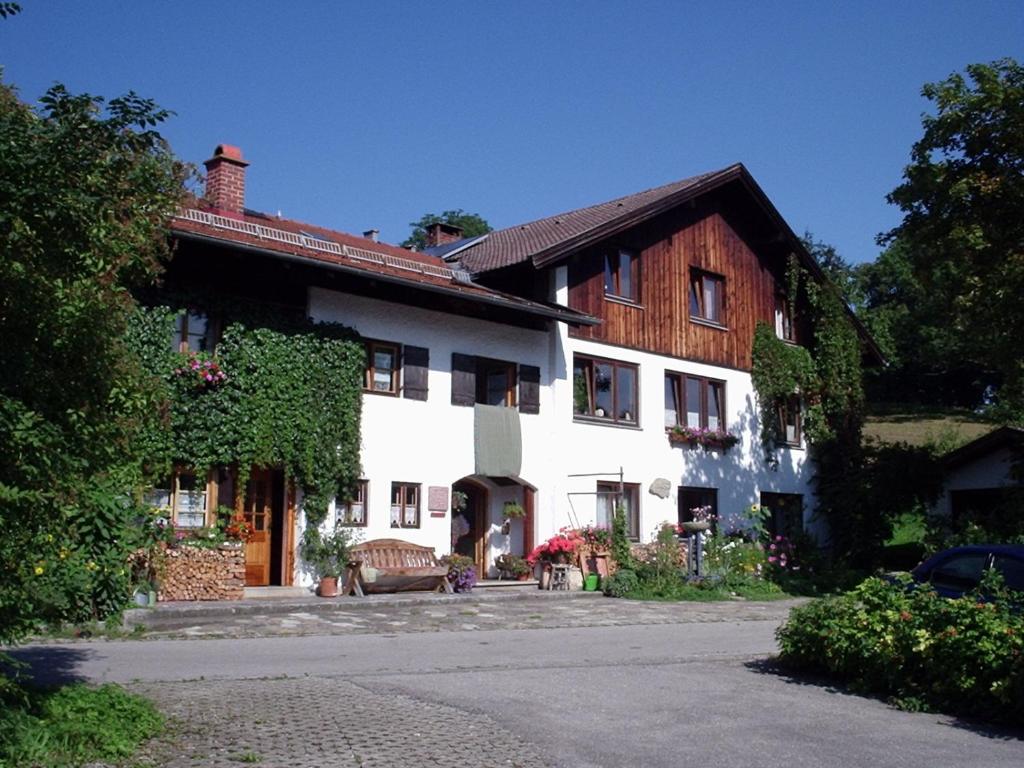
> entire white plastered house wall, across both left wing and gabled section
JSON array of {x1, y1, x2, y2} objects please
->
[{"x1": 300, "y1": 276, "x2": 813, "y2": 589}]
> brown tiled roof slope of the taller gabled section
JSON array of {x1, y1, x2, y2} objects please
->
[{"x1": 461, "y1": 164, "x2": 742, "y2": 272}]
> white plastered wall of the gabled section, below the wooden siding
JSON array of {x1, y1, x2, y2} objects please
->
[{"x1": 538, "y1": 267, "x2": 815, "y2": 541}]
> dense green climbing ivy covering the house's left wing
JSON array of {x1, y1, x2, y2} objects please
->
[{"x1": 129, "y1": 306, "x2": 366, "y2": 527}]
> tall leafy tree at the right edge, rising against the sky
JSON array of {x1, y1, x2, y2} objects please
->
[{"x1": 881, "y1": 58, "x2": 1024, "y2": 419}]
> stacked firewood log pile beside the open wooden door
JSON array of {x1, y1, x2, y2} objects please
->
[{"x1": 157, "y1": 545, "x2": 246, "y2": 601}]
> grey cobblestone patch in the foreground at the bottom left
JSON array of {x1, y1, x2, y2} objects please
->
[{"x1": 131, "y1": 678, "x2": 545, "y2": 768}]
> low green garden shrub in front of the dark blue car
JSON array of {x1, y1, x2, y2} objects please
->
[{"x1": 777, "y1": 579, "x2": 1024, "y2": 725}]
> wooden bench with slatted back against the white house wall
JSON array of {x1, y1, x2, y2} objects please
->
[{"x1": 342, "y1": 539, "x2": 454, "y2": 597}]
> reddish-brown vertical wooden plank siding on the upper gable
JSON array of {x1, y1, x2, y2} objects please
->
[{"x1": 568, "y1": 199, "x2": 790, "y2": 371}]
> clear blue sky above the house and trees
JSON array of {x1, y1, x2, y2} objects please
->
[{"x1": 0, "y1": 0, "x2": 1024, "y2": 261}]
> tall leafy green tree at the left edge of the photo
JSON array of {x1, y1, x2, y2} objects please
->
[{"x1": 0, "y1": 84, "x2": 186, "y2": 642}]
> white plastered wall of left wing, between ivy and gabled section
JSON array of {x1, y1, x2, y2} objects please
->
[{"x1": 309, "y1": 289, "x2": 552, "y2": 581}]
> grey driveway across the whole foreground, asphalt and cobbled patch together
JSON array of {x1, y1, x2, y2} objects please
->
[{"x1": 9, "y1": 598, "x2": 1024, "y2": 768}]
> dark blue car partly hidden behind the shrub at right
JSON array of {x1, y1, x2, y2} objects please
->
[{"x1": 910, "y1": 544, "x2": 1024, "y2": 597}]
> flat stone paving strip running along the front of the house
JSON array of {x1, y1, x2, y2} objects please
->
[{"x1": 139, "y1": 593, "x2": 805, "y2": 638}]
